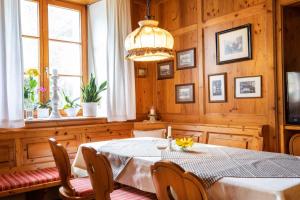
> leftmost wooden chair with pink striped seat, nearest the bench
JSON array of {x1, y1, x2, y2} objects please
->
[{"x1": 49, "y1": 138, "x2": 95, "y2": 200}]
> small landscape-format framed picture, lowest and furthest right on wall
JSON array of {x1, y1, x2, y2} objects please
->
[{"x1": 234, "y1": 76, "x2": 262, "y2": 98}]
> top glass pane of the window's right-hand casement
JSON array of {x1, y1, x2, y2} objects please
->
[{"x1": 48, "y1": 5, "x2": 81, "y2": 42}]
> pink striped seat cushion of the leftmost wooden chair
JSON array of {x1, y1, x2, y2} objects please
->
[{"x1": 70, "y1": 177, "x2": 94, "y2": 197}]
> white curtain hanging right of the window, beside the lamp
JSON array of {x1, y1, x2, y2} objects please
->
[{"x1": 107, "y1": 0, "x2": 136, "y2": 121}]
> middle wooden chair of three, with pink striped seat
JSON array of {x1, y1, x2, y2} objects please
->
[{"x1": 82, "y1": 147, "x2": 157, "y2": 200}]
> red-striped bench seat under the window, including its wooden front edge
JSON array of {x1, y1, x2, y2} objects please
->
[{"x1": 0, "y1": 167, "x2": 60, "y2": 197}]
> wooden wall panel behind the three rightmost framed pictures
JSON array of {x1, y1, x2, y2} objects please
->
[{"x1": 204, "y1": 1, "x2": 277, "y2": 151}]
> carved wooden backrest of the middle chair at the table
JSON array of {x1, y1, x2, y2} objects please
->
[{"x1": 82, "y1": 147, "x2": 114, "y2": 200}]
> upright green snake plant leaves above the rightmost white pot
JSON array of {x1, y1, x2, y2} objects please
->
[{"x1": 81, "y1": 74, "x2": 107, "y2": 103}]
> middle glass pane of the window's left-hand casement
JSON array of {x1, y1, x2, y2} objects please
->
[{"x1": 22, "y1": 37, "x2": 40, "y2": 71}]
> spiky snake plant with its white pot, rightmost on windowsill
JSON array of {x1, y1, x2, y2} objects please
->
[{"x1": 81, "y1": 74, "x2": 107, "y2": 117}]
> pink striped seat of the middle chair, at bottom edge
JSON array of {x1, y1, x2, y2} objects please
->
[{"x1": 110, "y1": 187, "x2": 157, "y2": 200}]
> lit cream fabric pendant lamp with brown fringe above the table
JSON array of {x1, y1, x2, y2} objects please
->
[{"x1": 125, "y1": 0, "x2": 174, "y2": 61}]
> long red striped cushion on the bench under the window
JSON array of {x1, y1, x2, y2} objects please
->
[{"x1": 0, "y1": 167, "x2": 60, "y2": 191}]
